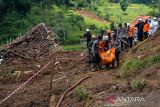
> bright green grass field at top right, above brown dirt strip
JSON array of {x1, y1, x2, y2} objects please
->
[{"x1": 95, "y1": 0, "x2": 151, "y2": 23}]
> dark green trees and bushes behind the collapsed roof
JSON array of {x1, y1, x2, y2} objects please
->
[{"x1": 0, "y1": 0, "x2": 104, "y2": 45}]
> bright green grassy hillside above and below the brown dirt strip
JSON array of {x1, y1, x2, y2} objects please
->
[{"x1": 62, "y1": 0, "x2": 152, "y2": 49}]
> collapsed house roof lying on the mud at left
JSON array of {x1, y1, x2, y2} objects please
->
[{"x1": 2, "y1": 23, "x2": 62, "y2": 59}]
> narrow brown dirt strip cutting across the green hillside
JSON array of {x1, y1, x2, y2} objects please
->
[{"x1": 76, "y1": 9, "x2": 109, "y2": 24}]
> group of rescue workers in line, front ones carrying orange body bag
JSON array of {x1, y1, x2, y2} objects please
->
[{"x1": 84, "y1": 17, "x2": 160, "y2": 70}]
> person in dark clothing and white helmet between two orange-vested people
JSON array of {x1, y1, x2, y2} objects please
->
[{"x1": 135, "y1": 19, "x2": 144, "y2": 41}]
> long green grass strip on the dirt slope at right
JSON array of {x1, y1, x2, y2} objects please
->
[{"x1": 120, "y1": 54, "x2": 160, "y2": 78}]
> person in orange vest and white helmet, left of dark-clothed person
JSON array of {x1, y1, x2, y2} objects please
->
[{"x1": 127, "y1": 23, "x2": 135, "y2": 48}]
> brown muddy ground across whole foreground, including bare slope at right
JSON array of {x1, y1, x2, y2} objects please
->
[{"x1": 0, "y1": 32, "x2": 160, "y2": 107}]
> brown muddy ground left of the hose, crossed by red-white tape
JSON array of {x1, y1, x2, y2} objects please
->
[{"x1": 0, "y1": 52, "x2": 91, "y2": 107}]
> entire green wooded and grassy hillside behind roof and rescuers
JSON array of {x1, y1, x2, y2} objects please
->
[{"x1": 0, "y1": 0, "x2": 159, "y2": 44}]
